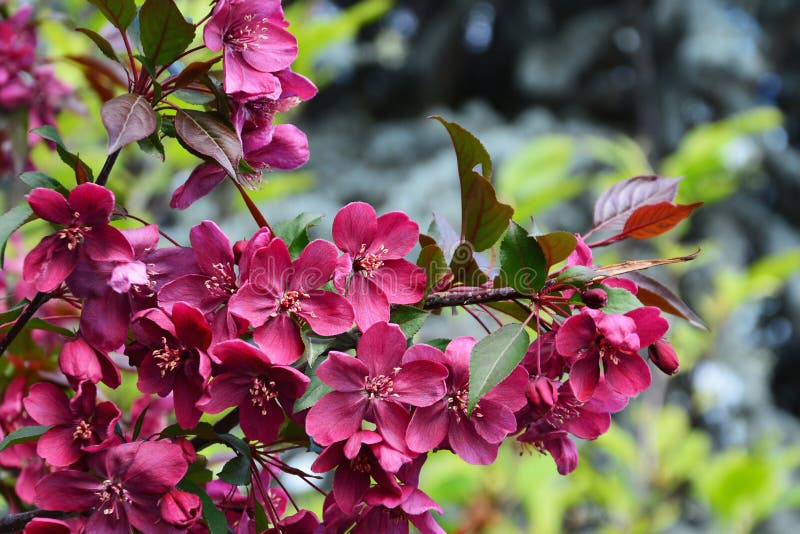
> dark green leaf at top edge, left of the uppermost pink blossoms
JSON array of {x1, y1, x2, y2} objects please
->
[{"x1": 139, "y1": 0, "x2": 195, "y2": 65}]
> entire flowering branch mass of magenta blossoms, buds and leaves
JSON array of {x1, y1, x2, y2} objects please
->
[{"x1": 0, "y1": 0, "x2": 691, "y2": 534}]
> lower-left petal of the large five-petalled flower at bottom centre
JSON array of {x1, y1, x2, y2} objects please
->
[{"x1": 306, "y1": 391, "x2": 367, "y2": 445}]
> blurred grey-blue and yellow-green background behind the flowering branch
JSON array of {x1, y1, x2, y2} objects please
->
[{"x1": 3, "y1": 0, "x2": 800, "y2": 533}]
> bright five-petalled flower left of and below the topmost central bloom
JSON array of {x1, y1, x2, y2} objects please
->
[{"x1": 228, "y1": 238, "x2": 353, "y2": 365}]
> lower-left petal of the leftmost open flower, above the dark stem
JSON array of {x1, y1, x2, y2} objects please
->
[{"x1": 22, "y1": 234, "x2": 78, "y2": 293}]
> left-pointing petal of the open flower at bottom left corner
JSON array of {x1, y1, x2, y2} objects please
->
[{"x1": 34, "y1": 471, "x2": 102, "y2": 512}]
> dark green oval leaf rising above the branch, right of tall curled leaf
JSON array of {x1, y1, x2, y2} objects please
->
[{"x1": 495, "y1": 221, "x2": 547, "y2": 294}]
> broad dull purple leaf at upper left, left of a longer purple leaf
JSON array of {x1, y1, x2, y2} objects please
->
[{"x1": 100, "y1": 94, "x2": 158, "y2": 154}]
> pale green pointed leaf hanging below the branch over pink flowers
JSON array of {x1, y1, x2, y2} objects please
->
[{"x1": 469, "y1": 324, "x2": 531, "y2": 413}]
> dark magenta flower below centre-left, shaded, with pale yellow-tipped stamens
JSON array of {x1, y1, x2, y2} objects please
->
[{"x1": 198, "y1": 339, "x2": 309, "y2": 444}]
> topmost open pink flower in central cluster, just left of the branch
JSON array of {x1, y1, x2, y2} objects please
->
[{"x1": 333, "y1": 202, "x2": 425, "y2": 331}]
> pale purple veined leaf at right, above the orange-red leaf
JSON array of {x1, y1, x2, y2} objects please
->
[{"x1": 594, "y1": 176, "x2": 681, "y2": 232}]
